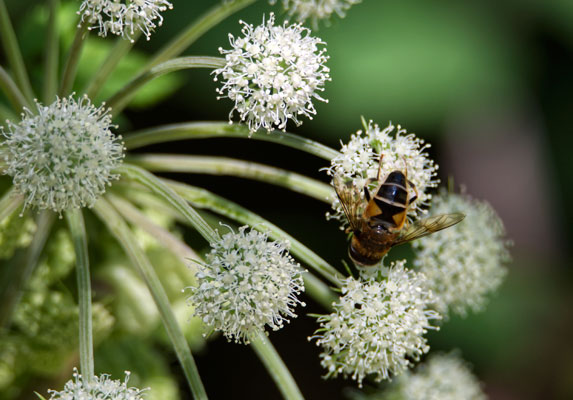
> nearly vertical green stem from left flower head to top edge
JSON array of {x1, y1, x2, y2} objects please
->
[{"x1": 43, "y1": 0, "x2": 60, "y2": 104}]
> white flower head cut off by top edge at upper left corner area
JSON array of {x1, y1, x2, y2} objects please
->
[{"x1": 78, "y1": 0, "x2": 173, "y2": 42}]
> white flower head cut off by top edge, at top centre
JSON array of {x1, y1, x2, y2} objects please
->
[{"x1": 270, "y1": 0, "x2": 362, "y2": 28}]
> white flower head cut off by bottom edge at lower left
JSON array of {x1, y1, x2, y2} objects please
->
[{"x1": 48, "y1": 368, "x2": 147, "y2": 400}]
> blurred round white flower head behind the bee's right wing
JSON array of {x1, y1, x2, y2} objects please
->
[{"x1": 412, "y1": 191, "x2": 510, "y2": 316}]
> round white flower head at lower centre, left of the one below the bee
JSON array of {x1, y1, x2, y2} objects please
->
[{"x1": 189, "y1": 226, "x2": 304, "y2": 343}]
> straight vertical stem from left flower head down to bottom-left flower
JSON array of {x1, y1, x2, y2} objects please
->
[{"x1": 66, "y1": 208, "x2": 94, "y2": 382}]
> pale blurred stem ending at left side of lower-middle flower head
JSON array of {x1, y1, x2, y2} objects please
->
[{"x1": 107, "y1": 194, "x2": 200, "y2": 265}]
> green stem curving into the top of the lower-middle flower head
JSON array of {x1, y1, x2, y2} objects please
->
[{"x1": 117, "y1": 164, "x2": 219, "y2": 243}]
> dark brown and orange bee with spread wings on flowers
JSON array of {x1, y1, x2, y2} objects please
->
[{"x1": 333, "y1": 155, "x2": 465, "y2": 266}]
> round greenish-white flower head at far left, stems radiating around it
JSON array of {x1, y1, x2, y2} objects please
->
[{"x1": 2, "y1": 96, "x2": 123, "y2": 213}]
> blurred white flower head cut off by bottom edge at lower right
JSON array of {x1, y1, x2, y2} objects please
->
[{"x1": 390, "y1": 354, "x2": 487, "y2": 400}]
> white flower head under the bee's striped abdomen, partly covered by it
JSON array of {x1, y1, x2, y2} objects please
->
[{"x1": 327, "y1": 121, "x2": 439, "y2": 229}]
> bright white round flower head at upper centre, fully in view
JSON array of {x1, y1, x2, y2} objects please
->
[{"x1": 213, "y1": 13, "x2": 330, "y2": 132}]
